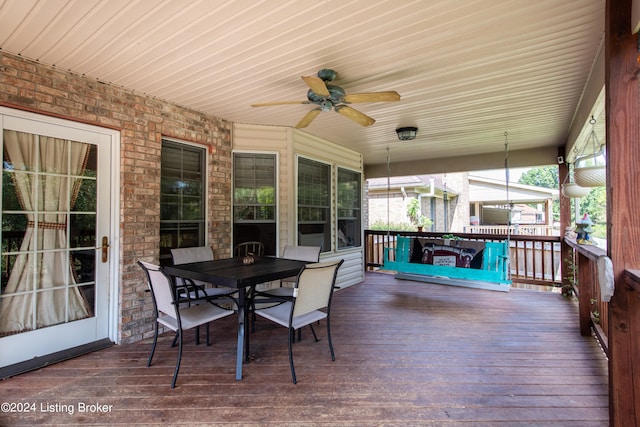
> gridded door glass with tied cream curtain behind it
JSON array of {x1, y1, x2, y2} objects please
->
[{"x1": 0, "y1": 129, "x2": 97, "y2": 336}]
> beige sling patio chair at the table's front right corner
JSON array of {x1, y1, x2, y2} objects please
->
[{"x1": 256, "y1": 259, "x2": 344, "y2": 384}]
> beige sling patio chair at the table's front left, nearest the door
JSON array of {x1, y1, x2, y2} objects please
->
[{"x1": 138, "y1": 261, "x2": 234, "y2": 388}]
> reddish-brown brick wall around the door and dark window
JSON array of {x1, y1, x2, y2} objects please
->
[{"x1": 0, "y1": 52, "x2": 231, "y2": 343}]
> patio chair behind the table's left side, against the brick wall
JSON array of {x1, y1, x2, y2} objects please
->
[{"x1": 171, "y1": 246, "x2": 236, "y2": 302}]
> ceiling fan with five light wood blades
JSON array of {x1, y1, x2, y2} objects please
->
[{"x1": 251, "y1": 68, "x2": 400, "y2": 129}]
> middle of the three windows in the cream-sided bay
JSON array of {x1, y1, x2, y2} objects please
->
[{"x1": 298, "y1": 158, "x2": 331, "y2": 251}]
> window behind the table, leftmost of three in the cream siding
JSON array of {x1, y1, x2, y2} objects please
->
[{"x1": 233, "y1": 153, "x2": 277, "y2": 255}]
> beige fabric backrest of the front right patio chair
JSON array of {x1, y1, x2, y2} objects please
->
[{"x1": 292, "y1": 260, "x2": 344, "y2": 317}]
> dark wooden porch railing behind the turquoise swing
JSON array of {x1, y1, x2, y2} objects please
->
[{"x1": 365, "y1": 230, "x2": 562, "y2": 286}]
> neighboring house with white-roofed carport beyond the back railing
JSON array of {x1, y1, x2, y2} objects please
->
[{"x1": 367, "y1": 173, "x2": 558, "y2": 233}]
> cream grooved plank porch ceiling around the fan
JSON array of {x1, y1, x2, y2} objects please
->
[{"x1": 0, "y1": 0, "x2": 605, "y2": 173}]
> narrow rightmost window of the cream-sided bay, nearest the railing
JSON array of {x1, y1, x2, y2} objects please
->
[{"x1": 337, "y1": 168, "x2": 362, "y2": 249}]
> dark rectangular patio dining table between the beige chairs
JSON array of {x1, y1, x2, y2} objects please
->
[{"x1": 164, "y1": 257, "x2": 308, "y2": 381}]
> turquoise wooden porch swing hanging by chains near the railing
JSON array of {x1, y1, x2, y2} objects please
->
[{"x1": 382, "y1": 132, "x2": 512, "y2": 292}]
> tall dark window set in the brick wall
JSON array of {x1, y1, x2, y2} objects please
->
[{"x1": 160, "y1": 139, "x2": 206, "y2": 264}]
